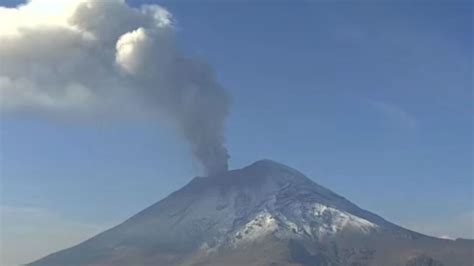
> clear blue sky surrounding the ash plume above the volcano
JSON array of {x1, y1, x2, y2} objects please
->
[{"x1": 0, "y1": 0, "x2": 474, "y2": 266}]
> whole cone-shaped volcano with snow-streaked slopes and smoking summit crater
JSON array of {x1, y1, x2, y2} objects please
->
[{"x1": 29, "y1": 160, "x2": 474, "y2": 266}]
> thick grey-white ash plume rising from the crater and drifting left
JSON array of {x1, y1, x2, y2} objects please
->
[{"x1": 0, "y1": 0, "x2": 230, "y2": 174}]
